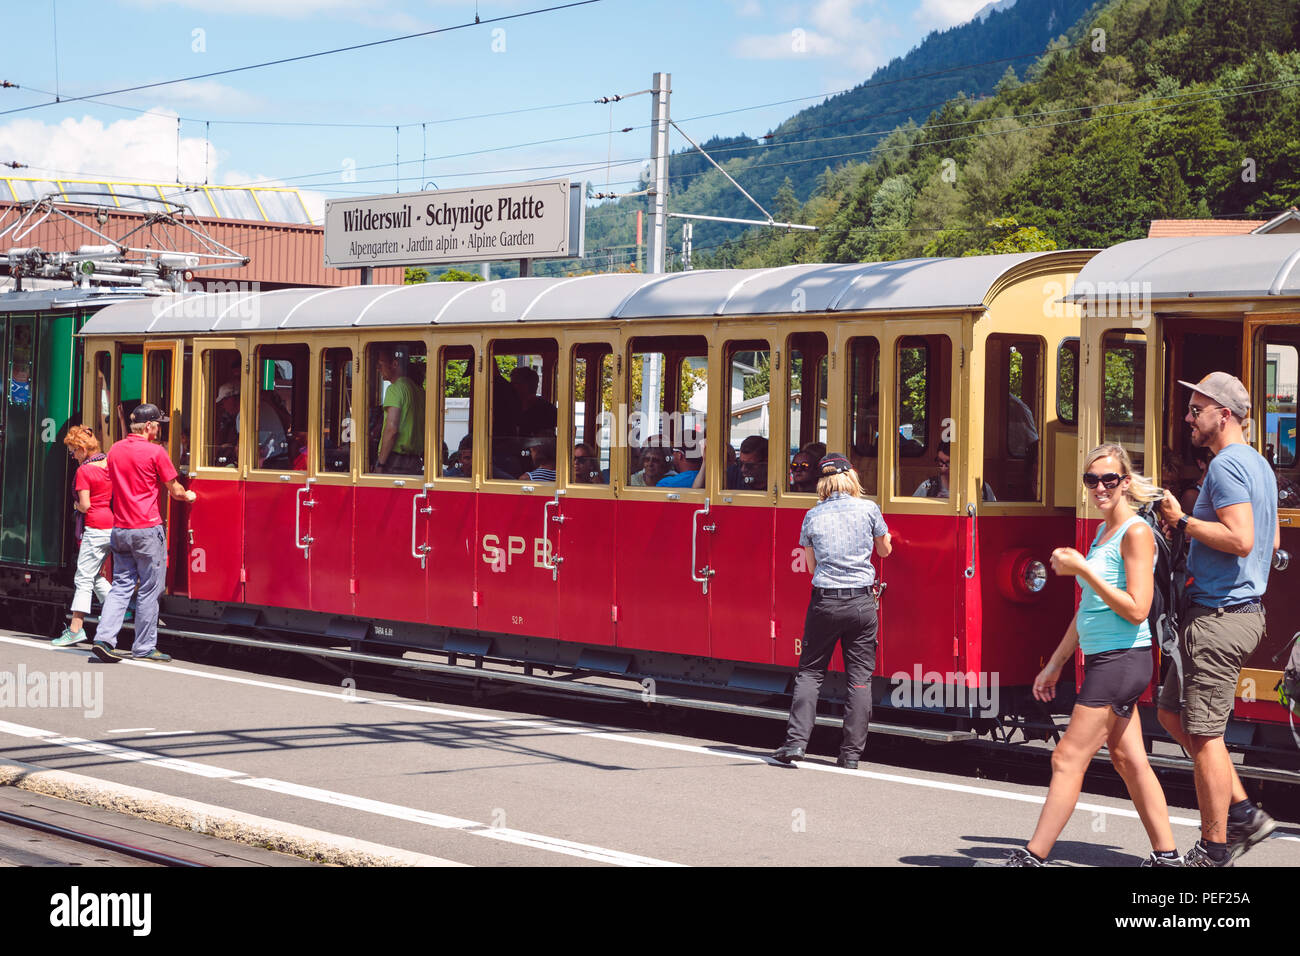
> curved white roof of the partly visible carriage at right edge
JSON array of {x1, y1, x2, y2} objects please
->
[{"x1": 1066, "y1": 233, "x2": 1300, "y2": 303}]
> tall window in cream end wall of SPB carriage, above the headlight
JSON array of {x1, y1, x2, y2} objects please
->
[{"x1": 983, "y1": 334, "x2": 1047, "y2": 501}]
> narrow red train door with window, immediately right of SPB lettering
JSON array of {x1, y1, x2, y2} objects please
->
[{"x1": 543, "y1": 330, "x2": 619, "y2": 644}]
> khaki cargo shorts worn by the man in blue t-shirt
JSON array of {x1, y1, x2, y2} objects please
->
[{"x1": 1158, "y1": 604, "x2": 1264, "y2": 737}]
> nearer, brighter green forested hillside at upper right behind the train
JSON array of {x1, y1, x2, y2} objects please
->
[{"x1": 694, "y1": 0, "x2": 1300, "y2": 268}]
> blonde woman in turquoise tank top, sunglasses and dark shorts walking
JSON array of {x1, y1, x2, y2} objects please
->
[{"x1": 987, "y1": 445, "x2": 1182, "y2": 866}]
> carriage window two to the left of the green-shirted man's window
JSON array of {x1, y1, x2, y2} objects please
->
[{"x1": 251, "y1": 345, "x2": 311, "y2": 471}]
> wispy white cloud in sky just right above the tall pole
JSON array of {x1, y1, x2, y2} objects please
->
[{"x1": 733, "y1": 0, "x2": 893, "y2": 73}]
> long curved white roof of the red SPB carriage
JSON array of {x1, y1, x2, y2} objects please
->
[{"x1": 82, "y1": 252, "x2": 1079, "y2": 336}]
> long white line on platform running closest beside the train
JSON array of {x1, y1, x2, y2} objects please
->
[{"x1": 0, "y1": 636, "x2": 1300, "y2": 839}]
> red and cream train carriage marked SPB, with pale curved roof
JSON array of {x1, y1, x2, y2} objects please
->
[{"x1": 68, "y1": 252, "x2": 1092, "y2": 724}]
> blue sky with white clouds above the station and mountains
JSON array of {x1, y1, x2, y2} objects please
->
[{"x1": 0, "y1": 0, "x2": 984, "y2": 218}]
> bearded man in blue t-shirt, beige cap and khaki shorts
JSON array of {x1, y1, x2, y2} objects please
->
[{"x1": 1158, "y1": 372, "x2": 1281, "y2": 866}]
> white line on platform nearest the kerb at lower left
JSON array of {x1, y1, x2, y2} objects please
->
[{"x1": 0, "y1": 721, "x2": 680, "y2": 866}]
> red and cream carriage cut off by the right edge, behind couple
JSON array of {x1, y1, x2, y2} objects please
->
[{"x1": 1070, "y1": 234, "x2": 1300, "y2": 769}]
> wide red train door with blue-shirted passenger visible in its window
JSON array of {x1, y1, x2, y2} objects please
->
[{"x1": 610, "y1": 329, "x2": 722, "y2": 657}]
